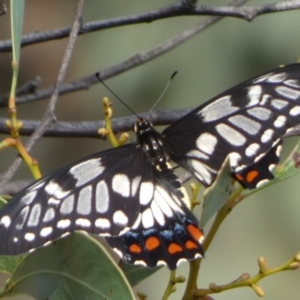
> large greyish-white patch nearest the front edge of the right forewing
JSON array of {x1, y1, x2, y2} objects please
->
[{"x1": 198, "y1": 96, "x2": 239, "y2": 123}]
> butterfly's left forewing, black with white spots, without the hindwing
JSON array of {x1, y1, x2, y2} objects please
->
[{"x1": 0, "y1": 144, "x2": 159, "y2": 254}]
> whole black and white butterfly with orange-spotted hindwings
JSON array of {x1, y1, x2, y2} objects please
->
[{"x1": 0, "y1": 64, "x2": 300, "y2": 269}]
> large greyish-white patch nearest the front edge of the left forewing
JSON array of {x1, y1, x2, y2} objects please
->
[{"x1": 69, "y1": 158, "x2": 104, "y2": 187}]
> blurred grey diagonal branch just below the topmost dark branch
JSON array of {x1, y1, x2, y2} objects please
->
[{"x1": 0, "y1": 0, "x2": 247, "y2": 106}]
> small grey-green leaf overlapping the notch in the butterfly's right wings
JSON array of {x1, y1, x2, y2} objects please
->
[{"x1": 200, "y1": 157, "x2": 232, "y2": 228}]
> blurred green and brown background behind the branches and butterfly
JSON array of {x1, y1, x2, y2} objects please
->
[{"x1": 0, "y1": 0, "x2": 300, "y2": 300}]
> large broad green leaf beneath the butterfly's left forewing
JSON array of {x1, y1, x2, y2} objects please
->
[{"x1": 0, "y1": 232, "x2": 135, "y2": 300}]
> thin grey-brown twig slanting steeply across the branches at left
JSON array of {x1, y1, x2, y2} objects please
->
[{"x1": 0, "y1": 0, "x2": 84, "y2": 190}]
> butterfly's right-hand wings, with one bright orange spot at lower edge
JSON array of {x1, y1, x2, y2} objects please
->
[{"x1": 163, "y1": 64, "x2": 300, "y2": 188}]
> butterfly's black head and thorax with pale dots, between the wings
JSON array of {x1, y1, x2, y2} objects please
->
[{"x1": 133, "y1": 119, "x2": 169, "y2": 171}]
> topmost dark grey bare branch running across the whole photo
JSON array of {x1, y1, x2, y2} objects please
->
[{"x1": 0, "y1": 0, "x2": 300, "y2": 52}]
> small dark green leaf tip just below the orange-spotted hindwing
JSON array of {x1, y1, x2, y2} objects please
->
[{"x1": 120, "y1": 261, "x2": 161, "y2": 286}]
